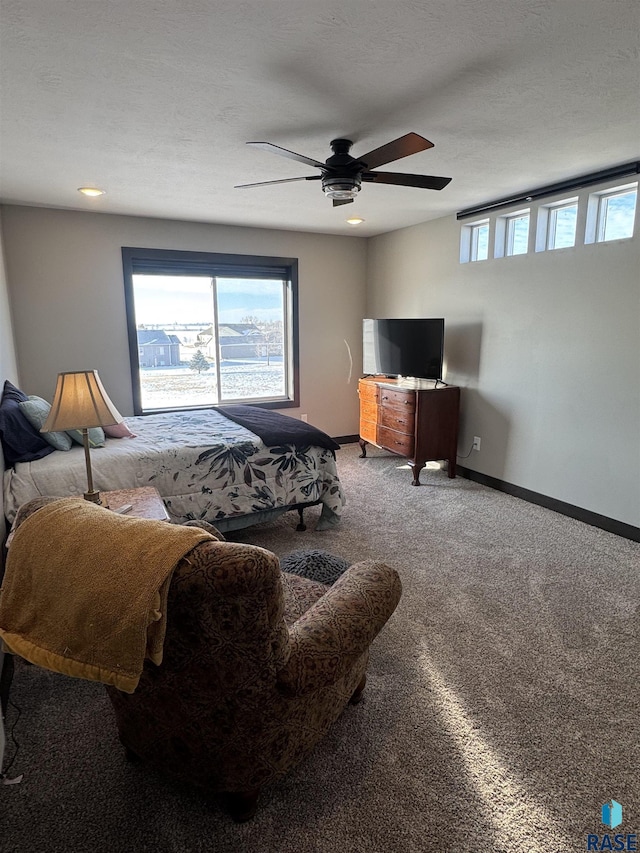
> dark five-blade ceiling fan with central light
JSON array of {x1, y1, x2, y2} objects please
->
[{"x1": 235, "y1": 133, "x2": 451, "y2": 207}]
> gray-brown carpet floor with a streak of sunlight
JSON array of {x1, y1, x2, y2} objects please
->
[{"x1": 0, "y1": 445, "x2": 640, "y2": 853}]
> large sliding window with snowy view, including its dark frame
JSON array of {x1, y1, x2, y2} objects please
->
[{"x1": 122, "y1": 248, "x2": 298, "y2": 414}]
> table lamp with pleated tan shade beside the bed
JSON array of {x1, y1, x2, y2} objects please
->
[{"x1": 40, "y1": 370, "x2": 122, "y2": 504}]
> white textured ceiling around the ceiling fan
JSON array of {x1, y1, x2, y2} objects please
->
[{"x1": 0, "y1": 0, "x2": 640, "y2": 235}]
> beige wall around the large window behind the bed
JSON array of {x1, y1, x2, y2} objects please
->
[{"x1": 2, "y1": 205, "x2": 366, "y2": 436}]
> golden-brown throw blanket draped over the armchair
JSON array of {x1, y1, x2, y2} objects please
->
[{"x1": 0, "y1": 498, "x2": 214, "y2": 693}]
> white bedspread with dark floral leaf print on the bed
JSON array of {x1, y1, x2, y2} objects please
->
[{"x1": 4, "y1": 409, "x2": 345, "y2": 528}]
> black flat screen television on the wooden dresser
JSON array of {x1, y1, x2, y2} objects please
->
[{"x1": 362, "y1": 317, "x2": 444, "y2": 379}]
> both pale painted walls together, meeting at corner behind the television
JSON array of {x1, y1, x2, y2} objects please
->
[{"x1": 0, "y1": 196, "x2": 640, "y2": 526}]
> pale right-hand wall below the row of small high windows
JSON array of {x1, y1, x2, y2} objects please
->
[{"x1": 367, "y1": 191, "x2": 640, "y2": 526}]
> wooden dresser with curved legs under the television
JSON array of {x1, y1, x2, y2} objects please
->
[{"x1": 358, "y1": 376, "x2": 460, "y2": 486}]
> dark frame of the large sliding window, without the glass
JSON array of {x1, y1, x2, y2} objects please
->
[{"x1": 122, "y1": 246, "x2": 300, "y2": 415}]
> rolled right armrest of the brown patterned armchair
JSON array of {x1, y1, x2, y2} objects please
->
[{"x1": 277, "y1": 560, "x2": 402, "y2": 696}]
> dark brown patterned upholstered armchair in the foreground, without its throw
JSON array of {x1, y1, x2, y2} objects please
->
[{"x1": 8, "y1": 502, "x2": 401, "y2": 820}]
